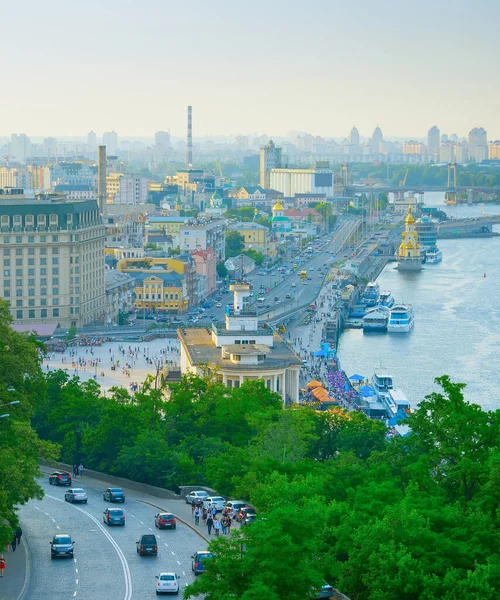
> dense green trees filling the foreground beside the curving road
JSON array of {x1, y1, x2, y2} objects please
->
[{"x1": 0, "y1": 290, "x2": 500, "y2": 600}]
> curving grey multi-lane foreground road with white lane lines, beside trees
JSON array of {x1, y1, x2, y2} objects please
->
[{"x1": 20, "y1": 477, "x2": 207, "y2": 600}]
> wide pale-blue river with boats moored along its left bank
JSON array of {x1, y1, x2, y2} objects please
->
[{"x1": 338, "y1": 193, "x2": 500, "y2": 410}]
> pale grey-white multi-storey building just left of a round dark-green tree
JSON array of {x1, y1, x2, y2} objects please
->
[{"x1": 179, "y1": 218, "x2": 226, "y2": 262}]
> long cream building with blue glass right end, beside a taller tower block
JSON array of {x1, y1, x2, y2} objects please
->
[{"x1": 270, "y1": 162, "x2": 333, "y2": 197}]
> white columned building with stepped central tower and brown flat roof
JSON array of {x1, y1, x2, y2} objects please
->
[{"x1": 177, "y1": 284, "x2": 302, "y2": 402}]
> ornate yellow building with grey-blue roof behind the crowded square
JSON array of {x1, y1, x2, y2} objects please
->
[{"x1": 116, "y1": 257, "x2": 192, "y2": 313}]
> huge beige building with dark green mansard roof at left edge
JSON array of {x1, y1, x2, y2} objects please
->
[{"x1": 0, "y1": 190, "x2": 105, "y2": 327}]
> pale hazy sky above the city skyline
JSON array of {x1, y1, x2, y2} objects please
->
[{"x1": 0, "y1": 0, "x2": 500, "y2": 139}]
